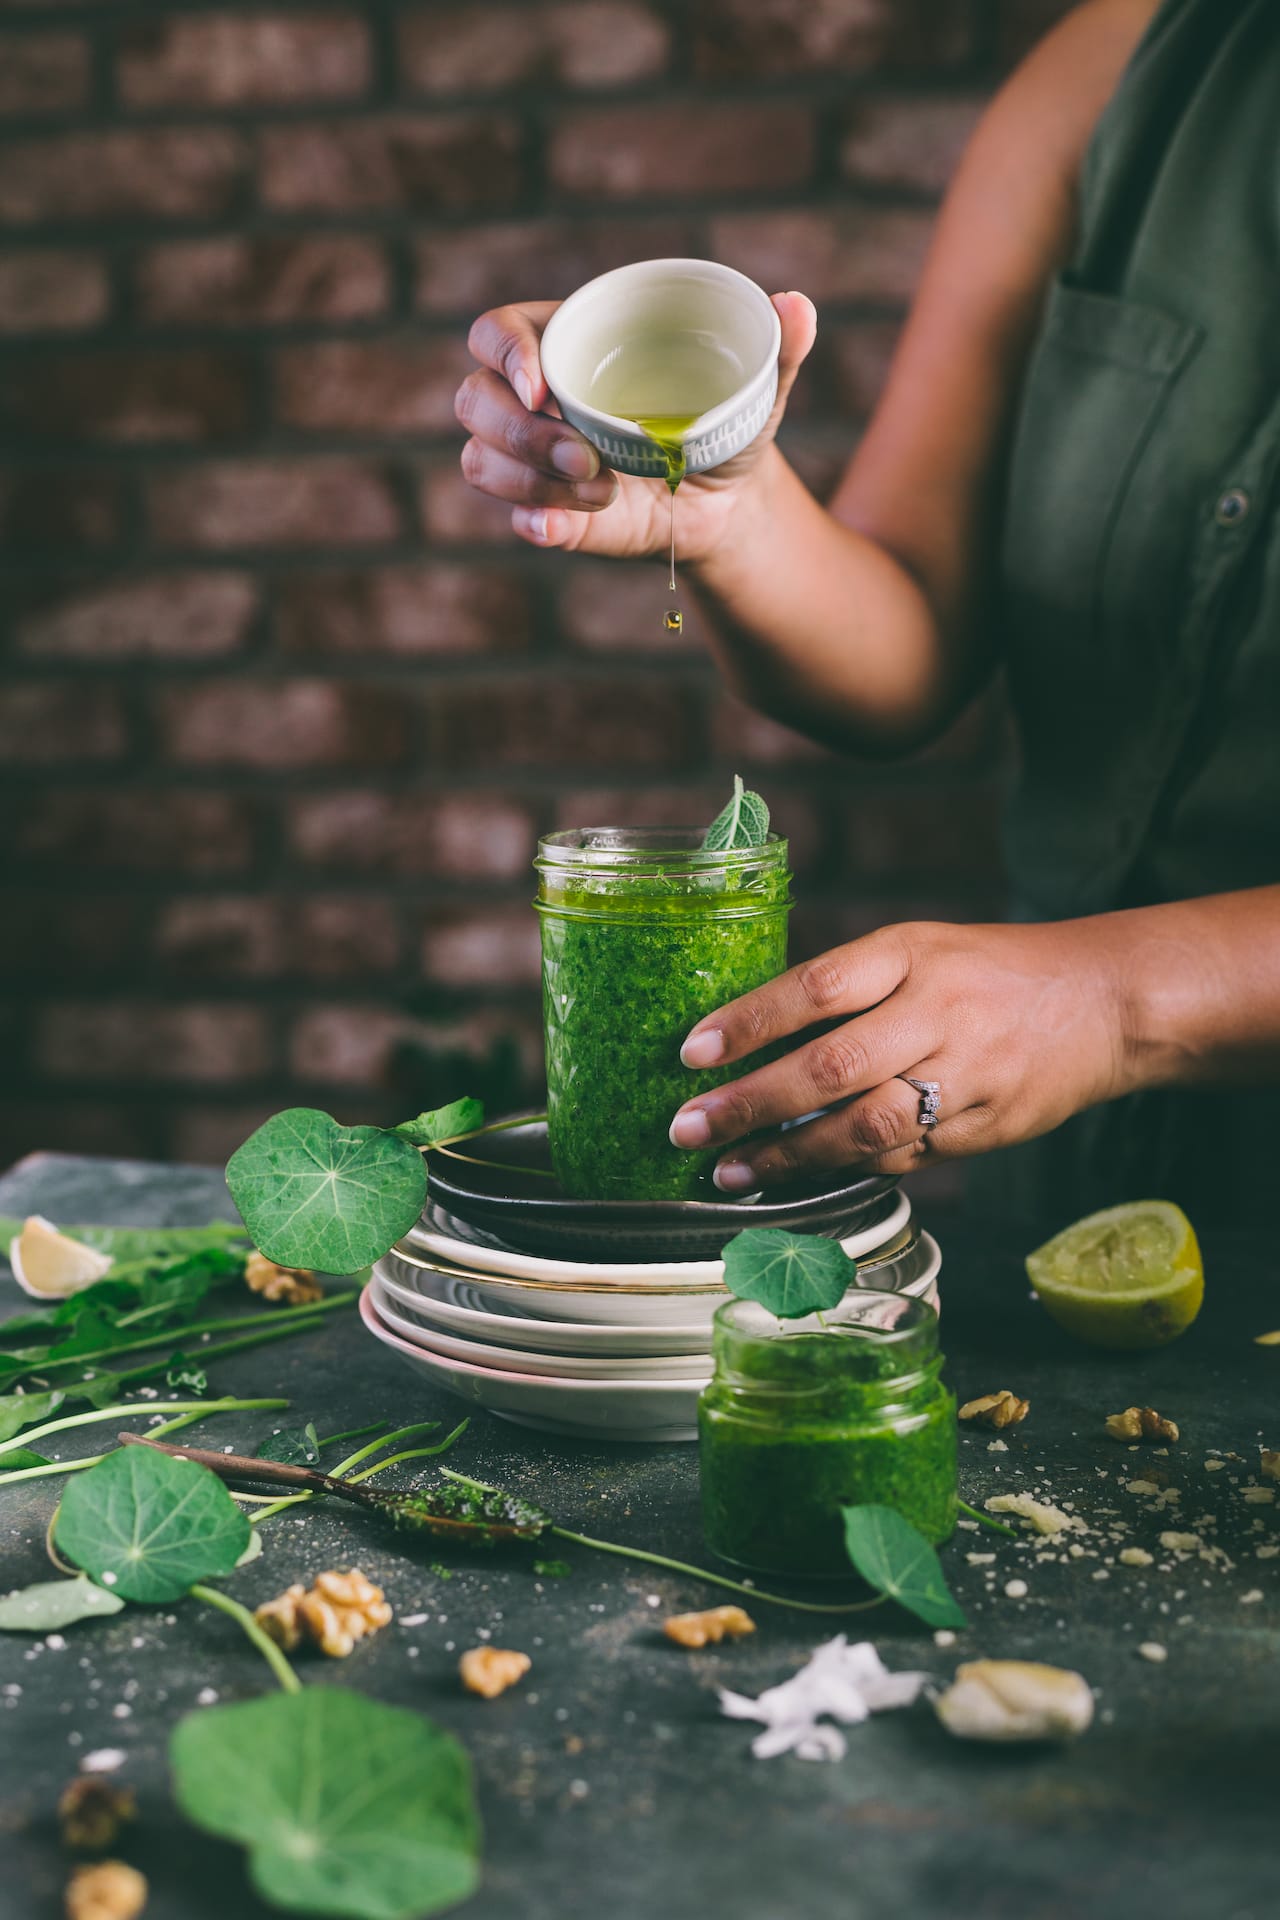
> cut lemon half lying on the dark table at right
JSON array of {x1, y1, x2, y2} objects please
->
[{"x1": 1027, "y1": 1200, "x2": 1205, "y2": 1350}]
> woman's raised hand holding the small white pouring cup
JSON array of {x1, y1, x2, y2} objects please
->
[{"x1": 455, "y1": 294, "x2": 818, "y2": 561}]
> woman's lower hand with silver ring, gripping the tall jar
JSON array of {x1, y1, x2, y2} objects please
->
[{"x1": 672, "y1": 916, "x2": 1136, "y2": 1192}]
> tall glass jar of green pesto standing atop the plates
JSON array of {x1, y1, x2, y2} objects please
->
[{"x1": 533, "y1": 828, "x2": 791, "y2": 1200}]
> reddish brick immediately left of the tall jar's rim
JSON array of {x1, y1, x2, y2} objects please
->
[{"x1": 288, "y1": 789, "x2": 535, "y2": 881}]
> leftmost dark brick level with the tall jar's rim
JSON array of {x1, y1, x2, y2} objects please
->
[{"x1": 12, "y1": 787, "x2": 257, "y2": 879}]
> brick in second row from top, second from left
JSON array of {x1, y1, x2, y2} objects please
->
[{"x1": 259, "y1": 113, "x2": 524, "y2": 215}]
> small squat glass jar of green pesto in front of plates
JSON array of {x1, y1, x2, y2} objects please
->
[{"x1": 699, "y1": 1288, "x2": 956, "y2": 1576}]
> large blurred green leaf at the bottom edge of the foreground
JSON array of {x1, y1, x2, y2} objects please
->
[{"x1": 169, "y1": 1688, "x2": 480, "y2": 1920}]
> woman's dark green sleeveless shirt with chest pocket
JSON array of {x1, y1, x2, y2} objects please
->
[{"x1": 971, "y1": 0, "x2": 1280, "y2": 1223}]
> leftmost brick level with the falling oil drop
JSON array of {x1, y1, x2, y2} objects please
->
[{"x1": 13, "y1": 572, "x2": 259, "y2": 660}]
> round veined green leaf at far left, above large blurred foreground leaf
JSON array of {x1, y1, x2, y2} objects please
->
[{"x1": 54, "y1": 1446, "x2": 249, "y2": 1605}]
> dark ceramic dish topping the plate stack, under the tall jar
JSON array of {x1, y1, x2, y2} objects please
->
[{"x1": 426, "y1": 1119, "x2": 898, "y2": 1261}]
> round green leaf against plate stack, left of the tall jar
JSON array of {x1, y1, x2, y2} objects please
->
[{"x1": 226, "y1": 1106, "x2": 426, "y2": 1273}]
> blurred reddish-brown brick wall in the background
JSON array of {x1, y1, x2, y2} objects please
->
[{"x1": 0, "y1": 0, "x2": 1063, "y2": 1162}]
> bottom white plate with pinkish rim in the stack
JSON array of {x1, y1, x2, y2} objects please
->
[{"x1": 361, "y1": 1283, "x2": 702, "y2": 1440}]
